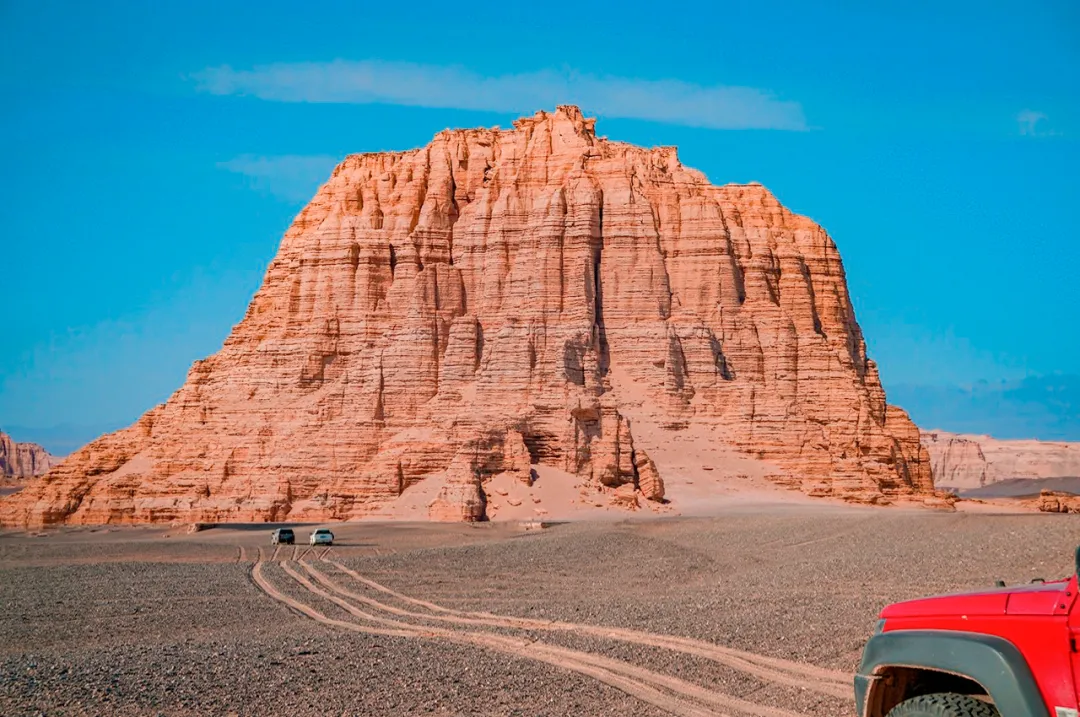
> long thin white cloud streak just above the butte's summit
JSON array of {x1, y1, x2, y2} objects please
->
[{"x1": 192, "y1": 60, "x2": 807, "y2": 131}]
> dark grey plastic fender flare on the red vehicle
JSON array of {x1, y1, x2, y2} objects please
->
[{"x1": 855, "y1": 630, "x2": 1050, "y2": 717}]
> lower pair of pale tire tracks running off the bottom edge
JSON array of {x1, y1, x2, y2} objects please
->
[{"x1": 256, "y1": 562, "x2": 797, "y2": 717}]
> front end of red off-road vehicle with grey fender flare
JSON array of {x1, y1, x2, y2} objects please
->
[{"x1": 855, "y1": 549, "x2": 1080, "y2": 717}]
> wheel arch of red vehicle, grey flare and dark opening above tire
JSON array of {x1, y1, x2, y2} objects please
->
[{"x1": 855, "y1": 630, "x2": 1049, "y2": 717}]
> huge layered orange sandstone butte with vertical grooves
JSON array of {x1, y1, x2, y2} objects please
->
[{"x1": 0, "y1": 106, "x2": 933, "y2": 525}]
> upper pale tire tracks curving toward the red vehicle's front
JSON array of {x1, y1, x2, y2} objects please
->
[{"x1": 324, "y1": 560, "x2": 851, "y2": 699}]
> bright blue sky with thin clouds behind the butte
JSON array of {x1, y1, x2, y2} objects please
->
[{"x1": 0, "y1": 0, "x2": 1080, "y2": 451}]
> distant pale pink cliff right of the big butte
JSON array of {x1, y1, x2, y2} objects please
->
[{"x1": 922, "y1": 431, "x2": 1080, "y2": 490}]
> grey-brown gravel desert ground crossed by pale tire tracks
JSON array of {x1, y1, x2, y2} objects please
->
[{"x1": 0, "y1": 505, "x2": 1080, "y2": 717}]
